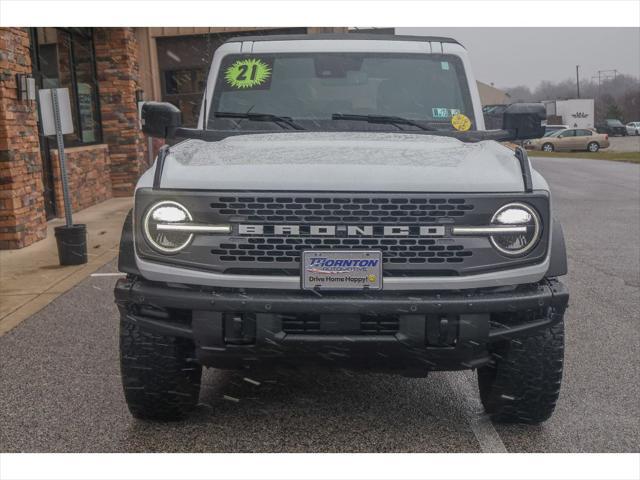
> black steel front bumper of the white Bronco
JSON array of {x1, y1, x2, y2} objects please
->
[{"x1": 115, "y1": 278, "x2": 569, "y2": 372}]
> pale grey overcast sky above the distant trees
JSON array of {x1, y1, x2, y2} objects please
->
[{"x1": 396, "y1": 27, "x2": 640, "y2": 88}]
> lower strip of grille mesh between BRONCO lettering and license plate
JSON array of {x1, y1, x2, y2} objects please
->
[{"x1": 211, "y1": 237, "x2": 473, "y2": 264}]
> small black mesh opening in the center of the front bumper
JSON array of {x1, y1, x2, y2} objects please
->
[{"x1": 282, "y1": 315, "x2": 400, "y2": 335}]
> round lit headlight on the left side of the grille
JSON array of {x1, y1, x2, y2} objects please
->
[{"x1": 143, "y1": 200, "x2": 193, "y2": 253}]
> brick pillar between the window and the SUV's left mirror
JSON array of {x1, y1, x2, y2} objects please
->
[{"x1": 94, "y1": 28, "x2": 147, "y2": 197}]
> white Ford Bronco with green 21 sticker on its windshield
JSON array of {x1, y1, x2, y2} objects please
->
[{"x1": 115, "y1": 34, "x2": 568, "y2": 423}]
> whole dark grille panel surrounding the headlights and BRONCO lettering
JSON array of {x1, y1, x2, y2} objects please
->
[{"x1": 134, "y1": 189, "x2": 549, "y2": 277}]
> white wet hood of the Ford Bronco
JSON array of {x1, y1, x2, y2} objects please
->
[{"x1": 161, "y1": 132, "x2": 524, "y2": 192}]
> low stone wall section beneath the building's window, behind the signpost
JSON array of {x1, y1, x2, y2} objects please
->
[{"x1": 51, "y1": 145, "x2": 111, "y2": 217}]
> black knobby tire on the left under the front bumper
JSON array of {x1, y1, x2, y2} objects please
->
[{"x1": 120, "y1": 319, "x2": 202, "y2": 420}]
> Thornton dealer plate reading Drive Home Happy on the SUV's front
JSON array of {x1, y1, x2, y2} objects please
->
[{"x1": 301, "y1": 250, "x2": 382, "y2": 290}]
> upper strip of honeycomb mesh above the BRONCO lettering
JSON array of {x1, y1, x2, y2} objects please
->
[{"x1": 211, "y1": 196, "x2": 474, "y2": 224}]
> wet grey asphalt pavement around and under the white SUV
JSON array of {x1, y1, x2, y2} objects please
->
[{"x1": 0, "y1": 158, "x2": 640, "y2": 452}]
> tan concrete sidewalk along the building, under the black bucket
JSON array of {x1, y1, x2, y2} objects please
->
[{"x1": 0, "y1": 197, "x2": 133, "y2": 336}]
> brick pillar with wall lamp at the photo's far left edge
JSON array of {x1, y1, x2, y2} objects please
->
[{"x1": 0, "y1": 28, "x2": 47, "y2": 250}]
